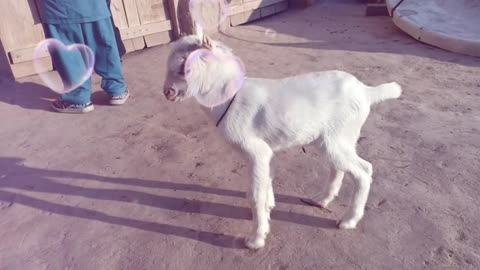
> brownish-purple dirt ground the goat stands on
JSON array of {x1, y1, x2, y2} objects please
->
[{"x1": 0, "y1": 0, "x2": 480, "y2": 270}]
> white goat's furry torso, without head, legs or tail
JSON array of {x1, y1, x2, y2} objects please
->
[{"x1": 223, "y1": 71, "x2": 370, "y2": 149}]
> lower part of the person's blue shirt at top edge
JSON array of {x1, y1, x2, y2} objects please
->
[{"x1": 37, "y1": 0, "x2": 111, "y2": 24}]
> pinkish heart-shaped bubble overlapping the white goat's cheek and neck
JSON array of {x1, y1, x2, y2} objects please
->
[{"x1": 185, "y1": 49, "x2": 245, "y2": 107}]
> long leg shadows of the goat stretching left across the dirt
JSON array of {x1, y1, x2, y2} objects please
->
[{"x1": 0, "y1": 157, "x2": 336, "y2": 248}]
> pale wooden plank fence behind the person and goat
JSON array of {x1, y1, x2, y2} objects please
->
[{"x1": 0, "y1": 0, "x2": 288, "y2": 78}]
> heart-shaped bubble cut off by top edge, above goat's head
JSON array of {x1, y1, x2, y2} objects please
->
[{"x1": 189, "y1": 0, "x2": 229, "y2": 31}]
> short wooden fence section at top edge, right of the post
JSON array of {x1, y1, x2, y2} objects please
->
[{"x1": 229, "y1": 0, "x2": 288, "y2": 26}]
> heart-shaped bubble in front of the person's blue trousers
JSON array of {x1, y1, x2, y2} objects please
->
[{"x1": 33, "y1": 39, "x2": 95, "y2": 94}]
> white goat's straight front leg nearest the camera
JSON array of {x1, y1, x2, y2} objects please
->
[{"x1": 245, "y1": 144, "x2": 274, "y2": 249}]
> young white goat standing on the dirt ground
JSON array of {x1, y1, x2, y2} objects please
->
[{"x1": 164, "y1": 33, "x2": 402, "y2": 249}]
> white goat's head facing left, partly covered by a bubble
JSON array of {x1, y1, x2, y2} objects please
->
[{"x1": 164, "y1": 34, "x2": 245, "y2": 107}]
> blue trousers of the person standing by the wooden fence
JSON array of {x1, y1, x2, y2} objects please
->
[{"x1": 44, "y1": 18, "x2": 127, "y2": 104}]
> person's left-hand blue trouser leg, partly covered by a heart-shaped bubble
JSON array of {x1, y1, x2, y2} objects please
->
[{"x1": 44, "y1": 24, "x2": 93, "y2": 108}]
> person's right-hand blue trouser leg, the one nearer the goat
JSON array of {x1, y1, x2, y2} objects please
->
[{"x1": 82, "y1": 18, "x2": 128, "y2": 104}]
